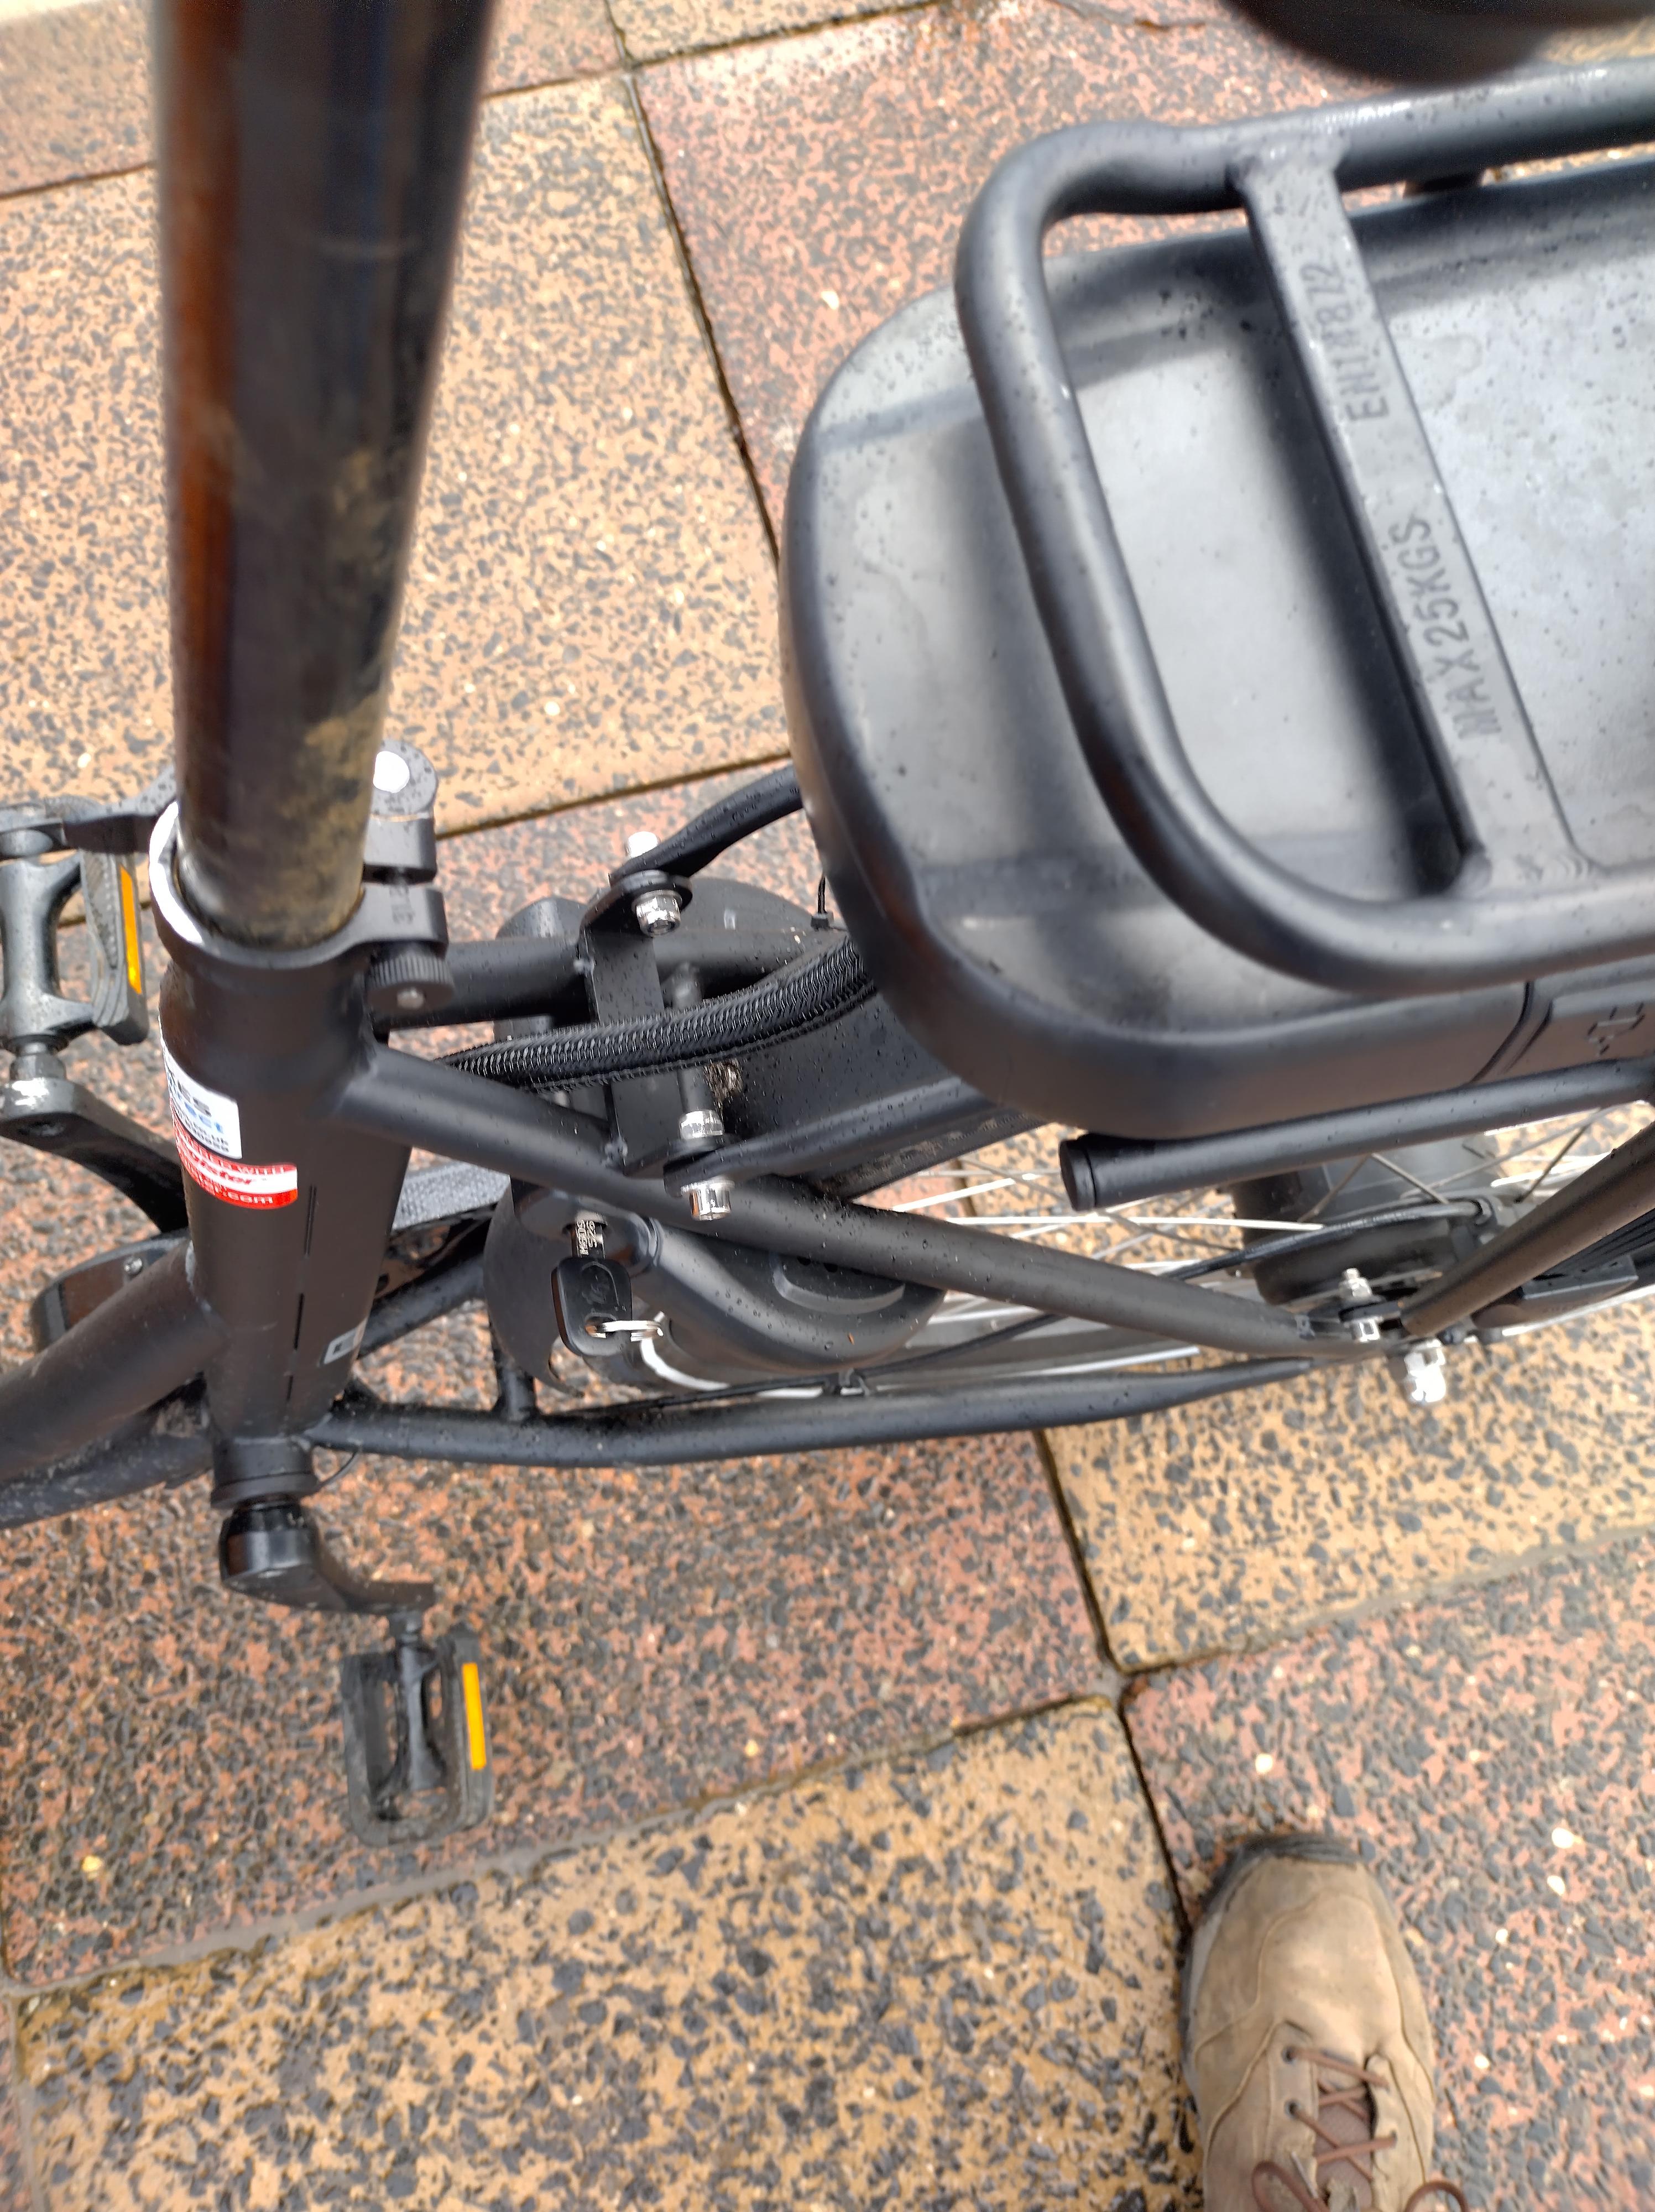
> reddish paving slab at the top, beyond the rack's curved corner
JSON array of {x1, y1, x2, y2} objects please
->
[{"x1": 639, "y1": 0, "x2": 1361, "y2": 518}]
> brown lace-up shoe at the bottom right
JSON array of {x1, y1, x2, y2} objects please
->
[{"x1": 1184, "y1": 1836, "x2": 1467, "y2": 2212}]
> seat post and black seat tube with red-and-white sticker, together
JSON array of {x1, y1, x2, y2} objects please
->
[{"x1": 150, "y1": 0, "x2": 491, "y2": 1504}]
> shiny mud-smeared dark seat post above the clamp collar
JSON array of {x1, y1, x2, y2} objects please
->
[{"x1": 155, "y1": 0, "x2": 493, "y2": 947}]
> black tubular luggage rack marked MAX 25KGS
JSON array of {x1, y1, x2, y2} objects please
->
[{"x1": 956, "y1": 62, "x2": 1655, "y2": 993}]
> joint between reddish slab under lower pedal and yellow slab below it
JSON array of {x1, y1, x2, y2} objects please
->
[{"x1": 0, "y1": 1677, "x2": 1110, "y2": 2022}]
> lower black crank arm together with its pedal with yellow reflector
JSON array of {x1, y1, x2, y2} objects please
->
[{"x1": 219, "y1": 1500, "x2": 493, "y2": 1847}]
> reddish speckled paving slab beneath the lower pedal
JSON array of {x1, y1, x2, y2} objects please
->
[{"x1": 0, "y1": 1416, "x2": 1100, "y2": 1984}]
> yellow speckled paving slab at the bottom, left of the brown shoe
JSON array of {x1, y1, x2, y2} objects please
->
[{"x1": 22, "y1": 1705, "x2": 1199, "y2": 2212}]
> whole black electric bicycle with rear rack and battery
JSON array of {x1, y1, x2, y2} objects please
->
[{"x1": 0, "y1": 0, "x2": 1655, "y2": 1845}]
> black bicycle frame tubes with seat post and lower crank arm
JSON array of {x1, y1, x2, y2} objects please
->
[{"x1": 0, "y1": 0, "x2": 1655, "y2": 1832}]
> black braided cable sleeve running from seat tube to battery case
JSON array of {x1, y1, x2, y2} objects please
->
[{"x1": 447, "y1": 936, "x2": 874, "y2": 1091}]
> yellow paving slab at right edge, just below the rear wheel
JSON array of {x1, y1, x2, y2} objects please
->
[{"x1": 1049, "y1": 1303, "x2": 1655, "y2": 1670}]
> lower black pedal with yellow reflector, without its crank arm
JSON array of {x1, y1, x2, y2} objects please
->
[{"x1": 338, "y1": 1615, "x2": 493, "y2": 1849}]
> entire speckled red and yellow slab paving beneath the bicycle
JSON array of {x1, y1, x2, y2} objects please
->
[{"x1": 0, "y1": 0, "x2": 1655, "y2": 2212}]
